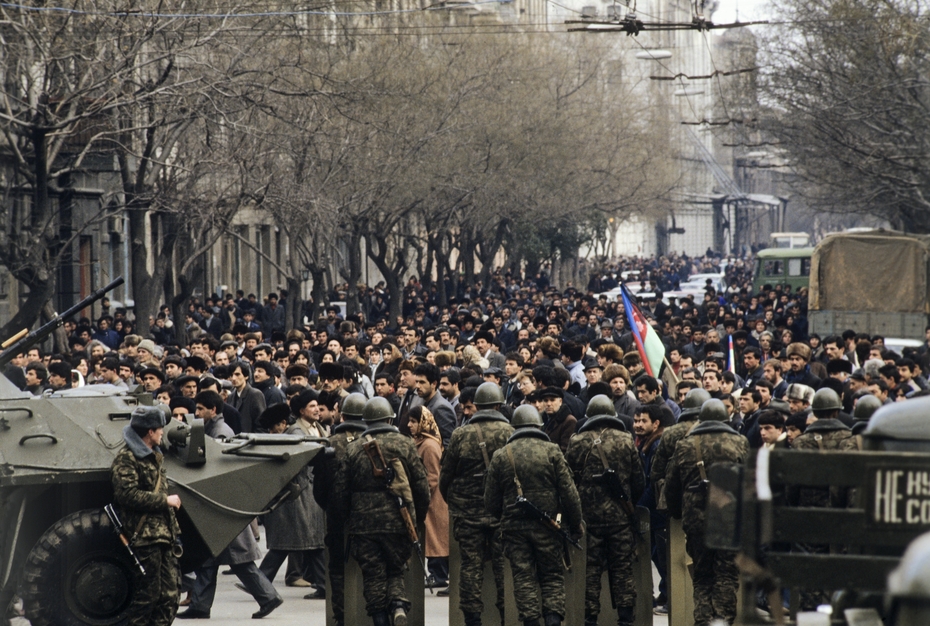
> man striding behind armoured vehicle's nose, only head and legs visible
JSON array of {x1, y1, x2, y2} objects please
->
[{"x1": 177, "y1": 391, "x2": 284, "y2": 619}]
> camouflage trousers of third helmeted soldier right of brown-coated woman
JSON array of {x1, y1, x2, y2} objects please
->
[{"x1": 584, "y1": 525, "x2": 636, "y2": 620}]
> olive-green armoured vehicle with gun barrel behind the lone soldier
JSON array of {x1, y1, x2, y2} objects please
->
[{"x1": 0, "y1": 280, "x2": 325, "y2": 626}]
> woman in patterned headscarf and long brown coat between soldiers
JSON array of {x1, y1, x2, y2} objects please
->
[{"x1": 407, "y1": 406, "x2": 449, "y2": 587}]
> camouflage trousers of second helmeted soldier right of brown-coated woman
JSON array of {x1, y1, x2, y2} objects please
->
[{"x1": 503, "y1": 525, "x2": 565, "y2": 621}]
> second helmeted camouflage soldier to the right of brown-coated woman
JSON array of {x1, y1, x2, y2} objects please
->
[{"x1": 484, "y1": 404, "x2": 584, "y2": 626}]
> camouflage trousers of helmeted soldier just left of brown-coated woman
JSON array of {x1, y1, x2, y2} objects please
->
[{"x1": 349, "y1": 533, "x2": 410, "y2": 615}]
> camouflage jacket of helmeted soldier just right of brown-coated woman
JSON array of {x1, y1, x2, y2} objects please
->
[{"x1": 439, "y1": 411, "x2": 513, "y2": 524}]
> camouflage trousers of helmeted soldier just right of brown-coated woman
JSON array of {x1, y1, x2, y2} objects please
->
[{"x1": 452, "y1": 518, "x2": 504, "y2": 617}]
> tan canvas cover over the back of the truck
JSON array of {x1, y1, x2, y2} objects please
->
[{"x1": 808, "y1": 230, "x2": 930, "y2": 313}]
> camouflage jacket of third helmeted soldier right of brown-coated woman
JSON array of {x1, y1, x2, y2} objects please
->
[{"x1": 565, "y1": 417, "x2": 646, "y2": 528}]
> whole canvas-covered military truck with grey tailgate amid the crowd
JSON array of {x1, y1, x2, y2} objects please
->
[{"x1": 808, "y1": 229, "x2": 930, "y2": 339}]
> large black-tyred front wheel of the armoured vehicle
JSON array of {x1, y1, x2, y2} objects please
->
[{"x1": 22, "y1": 510, "x2": 135, "y2": 626}]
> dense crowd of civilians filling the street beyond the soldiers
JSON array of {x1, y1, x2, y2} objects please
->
[{"x1": 4, "y1": 249, "x2": 930, "y2": 604}]
